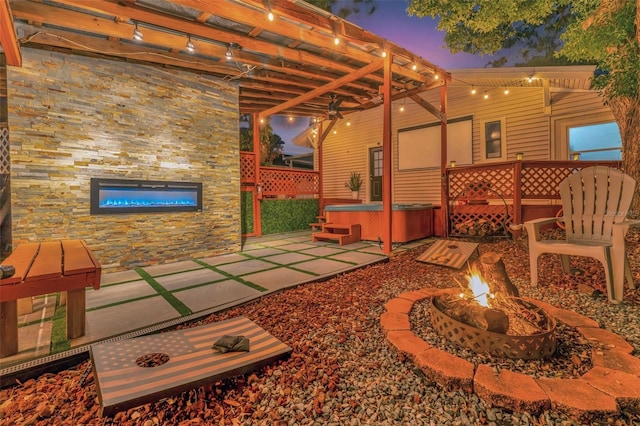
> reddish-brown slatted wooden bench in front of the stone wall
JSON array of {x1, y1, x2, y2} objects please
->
[{"x1": 0, "y1": 240, "x2": 101, "y2": 357}]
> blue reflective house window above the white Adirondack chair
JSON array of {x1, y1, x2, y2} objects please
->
[{"x1": 568, "y1": 121, "x2": 622, "y2": 161}]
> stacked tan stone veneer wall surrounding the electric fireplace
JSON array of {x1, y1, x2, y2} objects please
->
[{"x1": 7, "y1": 49, "x2": 241, "y2": 270}]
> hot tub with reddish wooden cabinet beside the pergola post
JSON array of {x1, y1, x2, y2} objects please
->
[{"x1": 324, "y1": 204, "x2": 433, "y2": 243}]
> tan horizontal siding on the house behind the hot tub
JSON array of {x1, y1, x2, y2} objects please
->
[{"x1": 323, "y1": 86, "x2": 609, "y2": 204}]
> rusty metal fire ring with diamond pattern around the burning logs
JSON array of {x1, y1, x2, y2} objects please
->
[{"x1": 429, "y1": 299, "x2": 557, "y2": 360}]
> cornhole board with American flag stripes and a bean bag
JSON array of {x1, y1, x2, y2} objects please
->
[{"x1": 90, "y1": 316, "x2": 291, "y2": 416}]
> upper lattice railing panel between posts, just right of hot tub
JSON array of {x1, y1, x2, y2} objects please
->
[{"x1": 449, "y1": 166, "x2": 514, "y2": 198}]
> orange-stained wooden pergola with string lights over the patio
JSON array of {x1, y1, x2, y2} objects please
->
[{"x1": 0, "y1": 0, "x2": 450, "y2": 253}]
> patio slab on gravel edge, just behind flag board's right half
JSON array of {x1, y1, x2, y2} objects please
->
[{"x1": 173, "y1": 280, "x2": 261, "y2": 312}]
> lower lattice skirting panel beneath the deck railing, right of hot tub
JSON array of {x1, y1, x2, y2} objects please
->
[{"x1": 450, "y1": 204, "x2": 513, "y2": 237}]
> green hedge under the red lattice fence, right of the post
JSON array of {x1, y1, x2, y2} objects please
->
[{"x1": 260, "y1": 198, "x2": 318, "y2": 235}]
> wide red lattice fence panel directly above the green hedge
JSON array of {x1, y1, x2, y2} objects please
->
[{"x1": 260, "y1": 167, "x2": 318, "y2": 195}]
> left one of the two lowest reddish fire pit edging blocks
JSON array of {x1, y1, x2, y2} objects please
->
[{"x1": 473, "y1": 364, "x2": 551, "y2": 415}]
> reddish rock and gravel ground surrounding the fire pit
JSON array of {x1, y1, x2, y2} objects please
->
[{"x1": 0, "y1": 232, "x2": 640, "y2": 426}]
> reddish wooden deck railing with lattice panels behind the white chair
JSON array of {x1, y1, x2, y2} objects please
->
[{"x1": 445, "y1": 161, "x2": 621, "y2": 236}]
